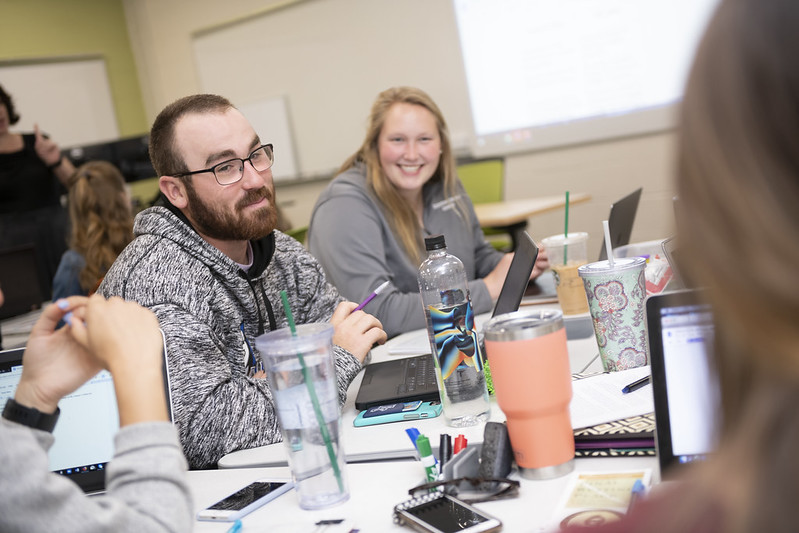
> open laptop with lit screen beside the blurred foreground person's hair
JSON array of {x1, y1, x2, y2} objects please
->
[{"x1": 646, "y1": 290, "x2": 720, "y2": 477}]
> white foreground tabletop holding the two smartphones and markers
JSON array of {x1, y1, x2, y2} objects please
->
[{"x1": 188, "y1": 457, "x2": 659, "y2": 533}]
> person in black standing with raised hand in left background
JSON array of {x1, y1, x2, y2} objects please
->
[{"x1": 0, "y1": 86, "x2": 75, "y2": 295}]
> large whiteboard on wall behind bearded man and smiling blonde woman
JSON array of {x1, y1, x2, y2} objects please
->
[{"x1": 192, "y1": 0, "x2": 471, "y2": 179}]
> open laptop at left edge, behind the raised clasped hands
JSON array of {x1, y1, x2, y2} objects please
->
[{"x1": 0, "y1": 330, "x2": 172, "y2": 494}]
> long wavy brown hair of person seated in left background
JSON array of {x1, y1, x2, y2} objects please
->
[{"x1": 69, "y1": 161, "x2": 133, "y2": 292}]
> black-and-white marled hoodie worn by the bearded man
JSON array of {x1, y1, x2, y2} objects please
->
[{"x1": 100, "y1": 206, "x2": 361, "y2": 468}]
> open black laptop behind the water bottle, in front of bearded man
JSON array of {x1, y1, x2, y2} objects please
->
[{"x1": 355, "y1": 232, "x2": 538, "y2": 411}]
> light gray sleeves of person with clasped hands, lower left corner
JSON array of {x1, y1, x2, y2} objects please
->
[{"x1": 0, "y1": 419, "x2": 194, "y2": 533}]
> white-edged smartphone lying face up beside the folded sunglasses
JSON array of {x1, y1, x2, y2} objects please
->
[{"x1": 394, "y1": 492, "x2": 502, "y2": 533}]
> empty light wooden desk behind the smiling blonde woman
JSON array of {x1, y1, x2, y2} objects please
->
[{"x1": 474, "y1": 193, "x2": 591, "y2": 250}]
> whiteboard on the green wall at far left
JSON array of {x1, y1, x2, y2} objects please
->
[{"x1": 0, "y1": 58, "x2": 119, "y2": 149}]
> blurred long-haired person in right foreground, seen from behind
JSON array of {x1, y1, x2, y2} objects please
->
[{"x1": 568, "y1": 0, "x2": 799, "y2": 533}]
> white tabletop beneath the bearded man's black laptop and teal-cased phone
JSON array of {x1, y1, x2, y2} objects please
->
[{"x1": 219, "y1": 306, "x2": 602, "y2": 468}]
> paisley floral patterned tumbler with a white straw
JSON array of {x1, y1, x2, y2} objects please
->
[{"x1": 577, "y1": 257, "x2": 649, "y2": 372}]
